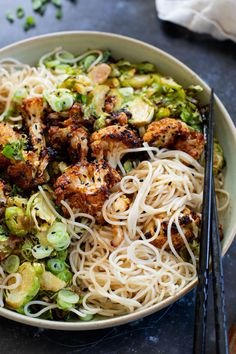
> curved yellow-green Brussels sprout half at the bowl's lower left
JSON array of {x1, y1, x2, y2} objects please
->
[{"x1": 5, "y1": 262, "x2": 40, "y2": 309}]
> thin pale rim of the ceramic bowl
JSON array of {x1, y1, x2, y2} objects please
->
[{"x1": 0, "y1": 31, "x2": 236, "y2": 331}]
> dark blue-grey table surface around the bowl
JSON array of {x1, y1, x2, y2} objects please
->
[{"x1": 0, "y1": 0, "x2": 236, "y2": 354}]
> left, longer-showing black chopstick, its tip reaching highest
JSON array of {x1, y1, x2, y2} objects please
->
[{"x1": 193, "y1": 90, "x2": 214, "y2": 354}]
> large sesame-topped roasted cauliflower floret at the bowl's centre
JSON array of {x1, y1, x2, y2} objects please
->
[{"x1": 55, "y1": 160, "x2": 121, "y2": 223}]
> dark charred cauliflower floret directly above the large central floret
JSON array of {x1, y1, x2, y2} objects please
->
[{"x1": 48, "y1": 125, "x2": 88, "y2": 162}]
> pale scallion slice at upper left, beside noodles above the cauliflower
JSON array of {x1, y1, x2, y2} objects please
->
[{"x1": 44, "y1": 88, "x2": 74, "y2": 112}]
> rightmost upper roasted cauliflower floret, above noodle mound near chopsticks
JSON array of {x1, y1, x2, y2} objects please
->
[{"x1": 143, "y1": 118, "x2": 204, "y2": 160}]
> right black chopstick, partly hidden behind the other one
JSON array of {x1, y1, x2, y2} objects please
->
[{"x1": 211, "y1": 178, "x2": 229, "y2": 354}]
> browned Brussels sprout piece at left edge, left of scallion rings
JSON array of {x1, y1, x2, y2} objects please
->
[{"x1": 5, "y1": 206, "x2": 30, "y2": 236}]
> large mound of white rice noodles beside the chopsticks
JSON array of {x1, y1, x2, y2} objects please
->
[{"x1": 70, "y1": 148, "x2": 204, "y2": 316}]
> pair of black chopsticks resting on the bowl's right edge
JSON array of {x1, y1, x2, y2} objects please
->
[{"x1": 193, "y1": 90, "x2": 229, "y2": 354}]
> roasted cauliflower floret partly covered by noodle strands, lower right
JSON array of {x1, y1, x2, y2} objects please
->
[{"x1": 145, "y1": 208, "x2": 201, "y2": 249}]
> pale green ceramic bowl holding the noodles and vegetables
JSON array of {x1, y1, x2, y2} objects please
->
[{"x1": 0, "y1": 32, "x2": 236, "y2": 330}]
